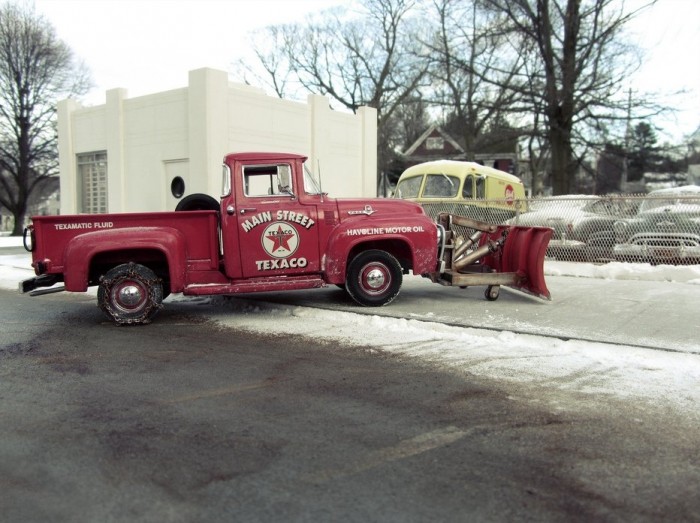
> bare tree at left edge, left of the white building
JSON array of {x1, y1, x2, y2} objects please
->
[{"x1": 0, "y1": 3, "x2": 89, "y2": 235}]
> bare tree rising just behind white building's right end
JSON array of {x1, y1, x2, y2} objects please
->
[{"x1": 238, "y1": 0, "x2": 427, "y2": 184}]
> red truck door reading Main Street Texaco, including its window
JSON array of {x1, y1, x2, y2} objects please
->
[{"x1": 234, "y1": 162, "x2": 320, "y2": 278}]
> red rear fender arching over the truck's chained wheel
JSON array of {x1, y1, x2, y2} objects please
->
[{"x1": 63, "y1": 227, "x2": 186, "y2": 292}]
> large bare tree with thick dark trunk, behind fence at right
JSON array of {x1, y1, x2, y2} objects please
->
[{"x1": 487, "y1": 0, "x2": 656, "y2": 194}]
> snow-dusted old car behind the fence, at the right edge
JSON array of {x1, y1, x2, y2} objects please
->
[{"x1": 613, "y1": 185, "x2": 700, "y2": 265}]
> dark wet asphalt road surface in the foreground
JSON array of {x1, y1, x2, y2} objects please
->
[{"x1": 0, "y1": 291, "x2": 700, "y2": 522}]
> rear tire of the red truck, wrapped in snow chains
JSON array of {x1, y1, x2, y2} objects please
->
[{"x1": 97, "y1": 263, "x2": 163, "y2": 325}]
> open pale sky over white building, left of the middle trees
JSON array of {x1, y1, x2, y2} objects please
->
[{"x1": 35, "y1": 0, "x2": 343, "y2": 105}]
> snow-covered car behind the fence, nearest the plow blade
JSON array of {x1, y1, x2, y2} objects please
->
[{"x1": 511, "y1": 195, "x2": 638, "y2": 262}]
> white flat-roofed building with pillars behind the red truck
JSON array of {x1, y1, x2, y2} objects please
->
[{"x1": 58, "y1": 69, "x2": 377, "y2": 214}]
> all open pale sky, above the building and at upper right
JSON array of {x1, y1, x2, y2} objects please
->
[{"x1": 30, "y1": 0, "x2": 700, "y2": 141}]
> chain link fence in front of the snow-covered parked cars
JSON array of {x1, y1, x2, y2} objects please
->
[{"x1": 422, "y1": 187, "x2": 700, "y2": 265}]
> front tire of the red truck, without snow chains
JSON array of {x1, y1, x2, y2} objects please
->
[{"x1": 345, "y1": 250, "x2": 403, "y2": 307}]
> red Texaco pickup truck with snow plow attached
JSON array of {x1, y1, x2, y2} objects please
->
[{"x1": 20, "y1": 153, "x2": 551, "y2": 324}]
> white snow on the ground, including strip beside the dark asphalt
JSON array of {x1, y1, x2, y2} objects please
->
[{"x1": 0, "y1": 237, "x2": 700, "y2": 418}]
